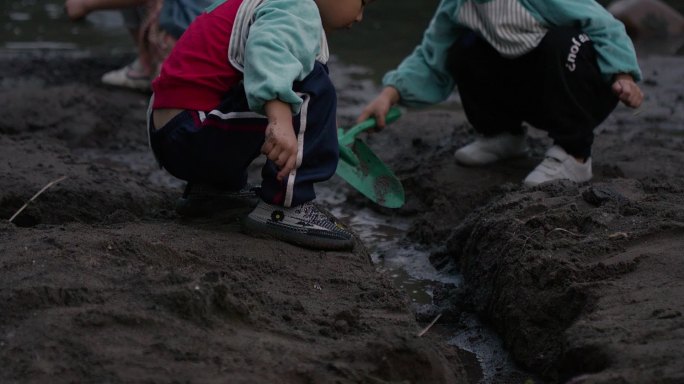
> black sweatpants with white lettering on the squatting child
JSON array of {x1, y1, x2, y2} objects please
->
[{"x1": 448, "y1": 27, "x2": 618, "y2": 158}]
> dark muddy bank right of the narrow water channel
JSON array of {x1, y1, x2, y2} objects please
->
[{"x1": 358, "y1": 56, "x2": 684, "y2": 384}]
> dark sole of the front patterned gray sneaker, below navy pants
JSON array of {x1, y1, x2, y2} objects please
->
[{"x1": 242, "y1": 217, "x2": 354, "y2": 251}]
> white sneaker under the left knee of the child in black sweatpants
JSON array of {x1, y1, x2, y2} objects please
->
[{"x1": 454, "y1": 132, "x2": 527, "y2": 165}]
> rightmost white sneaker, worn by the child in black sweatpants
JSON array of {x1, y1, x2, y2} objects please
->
[{"x1": 523, "y1": 145, "x2": 592, "y2": 187}]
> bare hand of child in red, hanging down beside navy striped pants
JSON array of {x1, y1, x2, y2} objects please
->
[{"x1": 261, "y1": 100, "x2": 297, "y2": 181}]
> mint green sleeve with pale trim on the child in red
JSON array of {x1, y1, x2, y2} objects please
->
[{"x1": 227, "y1": 0, "x2": 329, "y2": 114}]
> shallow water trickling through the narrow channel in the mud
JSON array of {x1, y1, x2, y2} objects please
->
[{"x1": 317, "y1": 188, "x2": 542, "y2": 383}]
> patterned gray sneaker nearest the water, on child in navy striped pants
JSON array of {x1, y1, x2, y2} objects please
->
[{"x1": 243, "y1": 201, "x2": 354, "y2": 250}]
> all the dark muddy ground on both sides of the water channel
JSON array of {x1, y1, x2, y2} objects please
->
[{"x1": 0, "y1": 48, "x2": 684, "y2": 383}]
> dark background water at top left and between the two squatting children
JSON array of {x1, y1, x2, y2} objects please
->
[{"x1": 0, "y1": 0, "x2": 439, "y2": 82}]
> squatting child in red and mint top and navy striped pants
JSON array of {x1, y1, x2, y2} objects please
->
[{"x1": 148, "y1": 0, "x2": 367, "y2": 249}]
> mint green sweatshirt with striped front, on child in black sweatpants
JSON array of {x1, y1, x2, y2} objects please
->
[{"x1": 383, "y1": 0, "x2": 641, "y2": 106}]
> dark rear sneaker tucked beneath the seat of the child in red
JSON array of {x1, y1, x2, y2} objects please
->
[{"x1": 176, "y1": 183, "x2": 260, "y2": 217}]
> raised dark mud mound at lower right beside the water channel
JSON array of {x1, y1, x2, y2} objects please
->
[{"x1": 438, "y1": 180, "x2": 684, "y2": 382}]
